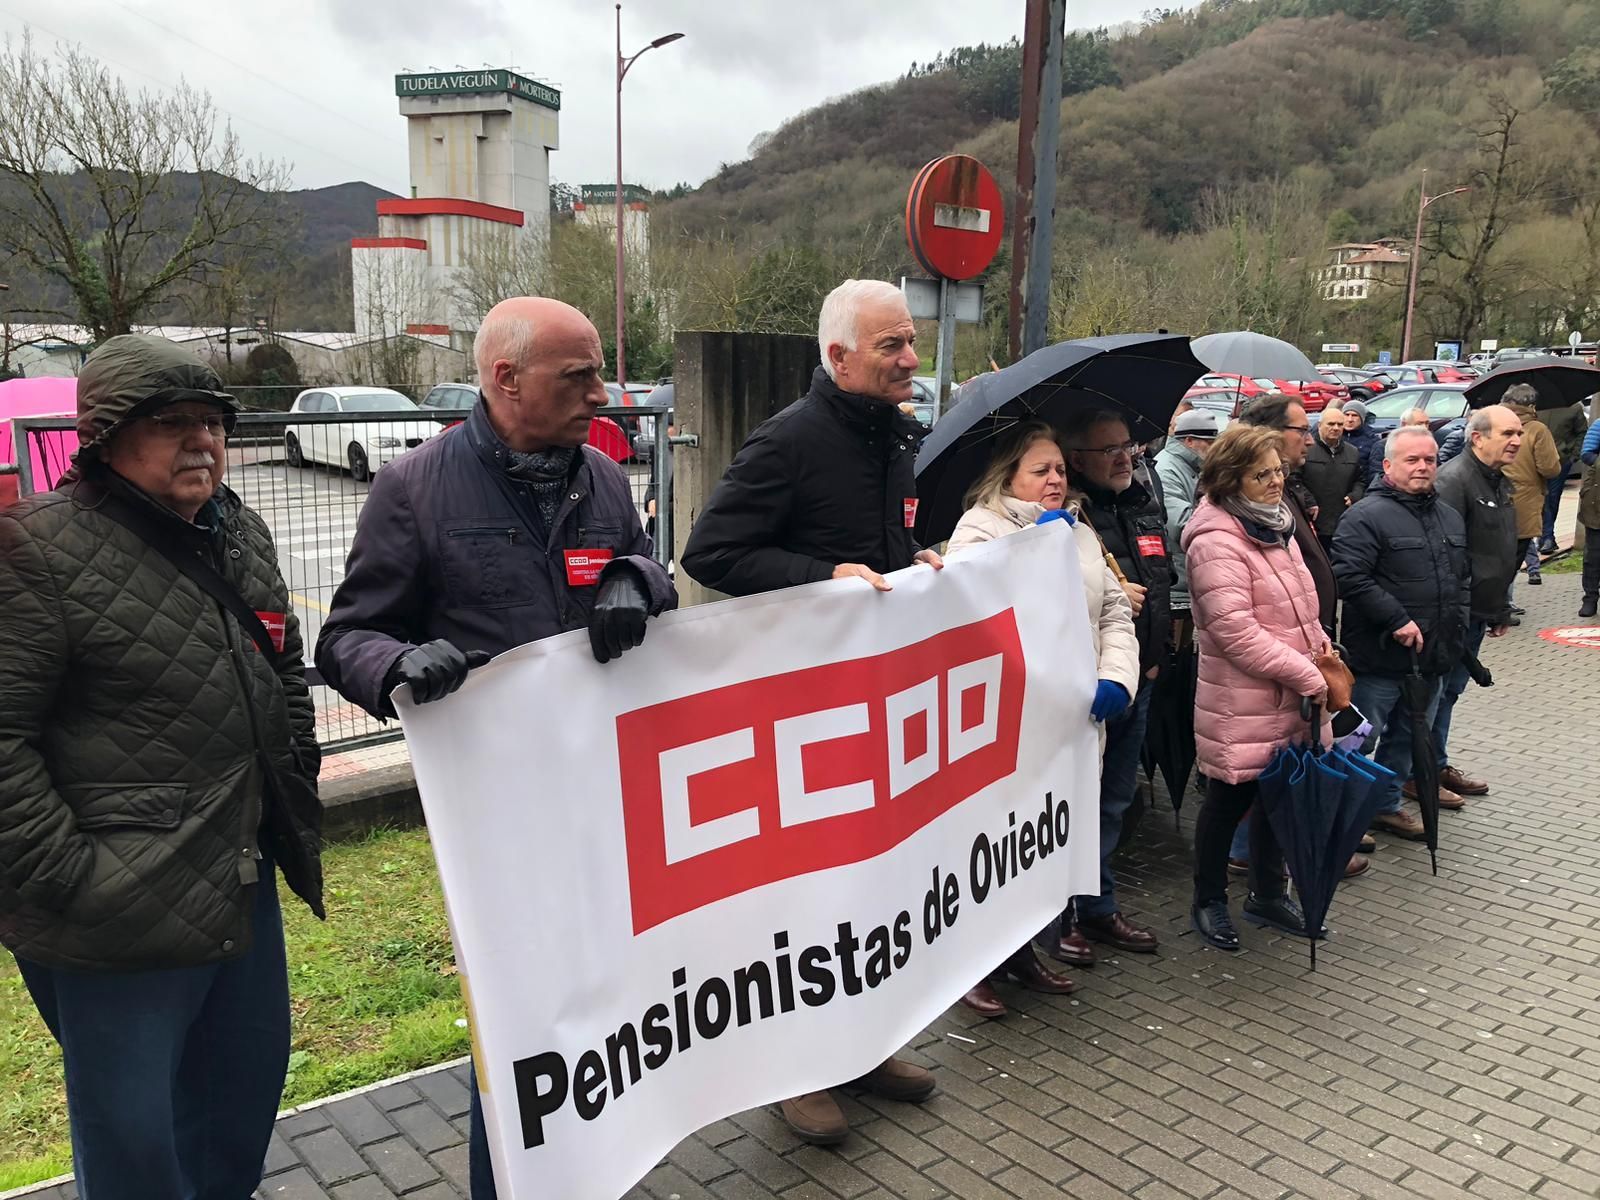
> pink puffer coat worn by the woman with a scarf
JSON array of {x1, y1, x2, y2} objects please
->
[{"x1": 1184, "y1": 499, "x2": 1328, "y2": 784}]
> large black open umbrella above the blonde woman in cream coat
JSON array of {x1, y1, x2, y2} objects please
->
[{"x1": 917, "y1": 333, "x2": 1205, "y2": 546}]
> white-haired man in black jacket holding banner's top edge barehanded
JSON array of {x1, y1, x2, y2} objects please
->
[{"x1": 683, "y1": 280, "x2": 944, "y2": 1146}]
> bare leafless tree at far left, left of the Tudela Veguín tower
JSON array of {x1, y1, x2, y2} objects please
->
[{"x1": 0, "y1": 35, "x2": 288, "y2": 339}]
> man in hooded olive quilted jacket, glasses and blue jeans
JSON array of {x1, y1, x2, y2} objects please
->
[{"x1": 0, "y1": 334, "x2": 323, "y2": 1200}]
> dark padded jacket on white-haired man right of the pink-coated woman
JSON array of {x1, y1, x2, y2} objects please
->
[{"x1": 1333, "y1": 480, "x2": 1472, "y2": 677}]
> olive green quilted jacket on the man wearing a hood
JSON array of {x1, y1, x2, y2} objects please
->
[{"x1": 0, "y1": 480, "x2": 323, "y2": 970}]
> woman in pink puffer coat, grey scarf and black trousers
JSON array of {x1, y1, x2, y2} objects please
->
[{"x1": 1182, "y1": 426, "x2": 1328, "y2": 950}]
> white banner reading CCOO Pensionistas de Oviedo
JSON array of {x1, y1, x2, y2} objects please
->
[{"x1": 395, "y1": 525, "x2": 1099, "y2": 1200}]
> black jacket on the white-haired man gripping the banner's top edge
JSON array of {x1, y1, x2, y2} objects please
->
[{"x1": 683, "y1": 366, "x2": 922, "y2": 595}]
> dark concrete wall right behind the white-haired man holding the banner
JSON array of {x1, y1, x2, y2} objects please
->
[{"x1": 672, "y1": 331, "x2": 821, "y2": 605}]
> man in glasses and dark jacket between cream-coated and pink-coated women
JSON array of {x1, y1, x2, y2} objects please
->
[{"x1": 1050, "y1": 410, "x2": 1174, "y2": 965}]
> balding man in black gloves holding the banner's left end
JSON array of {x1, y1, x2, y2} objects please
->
[{"x1": 317, "y1": 296, "x2": 678, "y2": 1200}]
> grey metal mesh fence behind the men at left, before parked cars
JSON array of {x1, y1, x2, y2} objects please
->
[{"x1": 13, "y1": 405, "x2": 672, "y2": 749}]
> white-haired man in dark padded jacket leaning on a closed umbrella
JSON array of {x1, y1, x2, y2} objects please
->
[{"x1": 1333, "y1": 426, "x2": 1472, "y2": 840}]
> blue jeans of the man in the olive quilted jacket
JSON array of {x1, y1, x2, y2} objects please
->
[{"x1": 16, "y1": 858, "x2": 290, "y2": 1200}]
